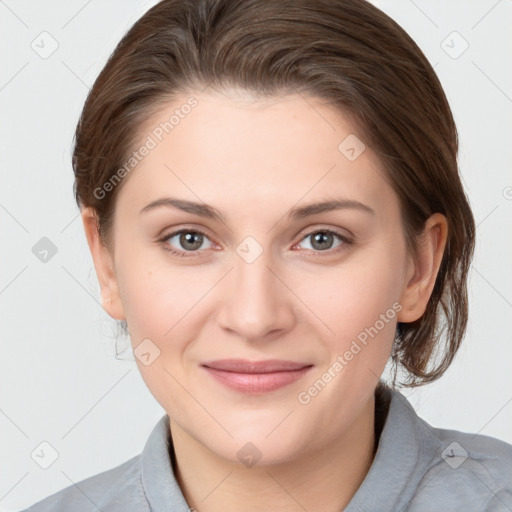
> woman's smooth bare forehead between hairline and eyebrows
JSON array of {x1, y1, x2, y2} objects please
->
[{"x1": 117, "y1": 90, "x2": 394, "y2": 220}]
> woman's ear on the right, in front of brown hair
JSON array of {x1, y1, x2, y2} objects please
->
[{"x1": 397, "y1": 213, "x2": 448, "y2": 323}]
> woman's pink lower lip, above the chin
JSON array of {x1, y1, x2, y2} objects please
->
[{"x1": 203, "y1": 366, "x2": 312, "y2": 395}]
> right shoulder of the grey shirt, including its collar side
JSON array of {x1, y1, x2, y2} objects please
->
[{"x1": 376, "y1": 388, "x2": 512, "y2": 512}]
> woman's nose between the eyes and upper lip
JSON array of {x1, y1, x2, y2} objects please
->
[{"x1": 219, "y1": 242, "x2": 295, "y2": 342}]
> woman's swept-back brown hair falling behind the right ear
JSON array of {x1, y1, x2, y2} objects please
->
[{"x1": 73, "y1": 0, "x2": 475, "y2": 386}]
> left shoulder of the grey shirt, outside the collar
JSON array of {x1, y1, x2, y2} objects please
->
[{"x1": 23, "y1": 455, "x2": 149, "y2": 512}]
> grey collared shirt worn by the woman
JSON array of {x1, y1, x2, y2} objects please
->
[{"x1": 20, "y1": 387, "x2": 512, "y2": 512}]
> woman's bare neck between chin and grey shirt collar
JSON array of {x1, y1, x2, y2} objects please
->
[{"x1": 170, "y1": 394, "x2": 376, "y2": 512}]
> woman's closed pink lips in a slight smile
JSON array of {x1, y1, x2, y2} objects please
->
[{"x1": 201, "y1": 359, "x2": 313, "y2": 395}]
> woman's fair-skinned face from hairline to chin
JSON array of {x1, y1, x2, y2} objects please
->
[{"x1": 86, "y1": 91, "x2": 430, "y2": 464}]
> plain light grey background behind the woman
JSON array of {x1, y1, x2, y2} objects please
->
[{"x1": 0, "y1": 0, "x2": 512, "y2": 511}]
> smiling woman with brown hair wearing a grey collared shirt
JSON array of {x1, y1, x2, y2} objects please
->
[{"x1": 20, "y1": 0, "x2": 512, "y2": 512}]
